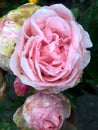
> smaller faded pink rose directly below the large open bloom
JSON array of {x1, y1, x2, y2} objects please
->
[{"x1": 23, "y1": 91, "x2": 70, "y2": 130}]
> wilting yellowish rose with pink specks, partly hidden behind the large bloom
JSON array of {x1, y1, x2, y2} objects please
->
[{"x1": 0, "y1": 4, "x2": 39, "y2": 71}]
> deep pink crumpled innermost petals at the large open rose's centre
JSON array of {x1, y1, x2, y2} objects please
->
[{"x1": 40, "y1": 39, "x2": 64, "y2": 64}]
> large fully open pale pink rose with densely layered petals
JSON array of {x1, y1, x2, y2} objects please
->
[{"x1": 10, "y1": 4, "x2": 92, "y2": 93}]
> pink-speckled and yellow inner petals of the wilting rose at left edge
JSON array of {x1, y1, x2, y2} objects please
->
[{"x1": 0, "y1": 17, "x2": 20, "y2": 57}]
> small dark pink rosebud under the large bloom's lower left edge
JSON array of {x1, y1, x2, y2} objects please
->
[{"x1": 14, "y1": 77, "x2": 31, "y2": 96}]
